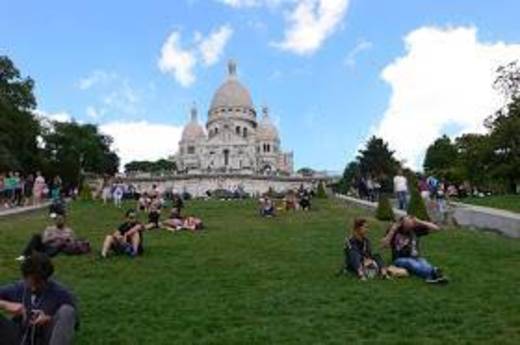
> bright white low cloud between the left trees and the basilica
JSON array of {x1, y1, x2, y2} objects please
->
[{"x1": 99, "y1": 121, "x2": 182, "y2": 167}]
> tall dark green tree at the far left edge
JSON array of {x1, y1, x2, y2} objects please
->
[{"x1": 0, "y1": 56, "x2": 40, "y2": 171}]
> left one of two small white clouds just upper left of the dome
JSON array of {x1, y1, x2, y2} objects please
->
[{"x1": 159, "y1": 31, "x2": 196, "y2": 87}]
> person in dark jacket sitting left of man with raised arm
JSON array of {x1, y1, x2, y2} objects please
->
[{"x1": 345, "y1": 218, "x2": 389, "y2": 280}]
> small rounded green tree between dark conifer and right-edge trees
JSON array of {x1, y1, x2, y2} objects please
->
[{"x1": 424, "y1": 135, "x2": 459, "y2": 180}]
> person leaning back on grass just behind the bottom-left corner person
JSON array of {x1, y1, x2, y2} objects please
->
[{"x1": 16, "y1": 213, "x2": 90, "y2": 261}]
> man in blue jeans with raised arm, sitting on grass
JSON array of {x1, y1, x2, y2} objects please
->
[{"x1": 381, "y1": 216, "x2": 448, "y2": 283}]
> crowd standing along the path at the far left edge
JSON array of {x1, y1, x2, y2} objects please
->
[{"x1": 0, "y1": 171, "x2": 64, "y2": 210}]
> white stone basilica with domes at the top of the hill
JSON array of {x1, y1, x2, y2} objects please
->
[{"x1": 175, "y1": 61, "x2": 293, "y2": 176}]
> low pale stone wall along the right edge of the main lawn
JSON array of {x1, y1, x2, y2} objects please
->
[{"x1": 336, "y1": 194, "x2": 520, "y2": 238}]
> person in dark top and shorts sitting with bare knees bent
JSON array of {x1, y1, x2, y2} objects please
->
[{"x1": 101, "y1": 209, "x2": 144, "y2": 258}]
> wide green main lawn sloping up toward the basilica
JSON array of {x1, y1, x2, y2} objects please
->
[{"x1": 0, "y1": 201, "x2": 520, "y2": 345}]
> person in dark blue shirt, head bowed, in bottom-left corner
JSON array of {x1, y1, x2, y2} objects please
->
[{"x1": 0, "y1": 253, "x2": 79, "y2": 345}]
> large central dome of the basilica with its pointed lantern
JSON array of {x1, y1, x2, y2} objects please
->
[{"x1": 211, "y1": 61, "x2": 253, "y2": 109}]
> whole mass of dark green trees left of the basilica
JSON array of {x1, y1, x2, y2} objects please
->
[{"x1": 0, "y1": 56, "x2": 119, "y2": 185}]
